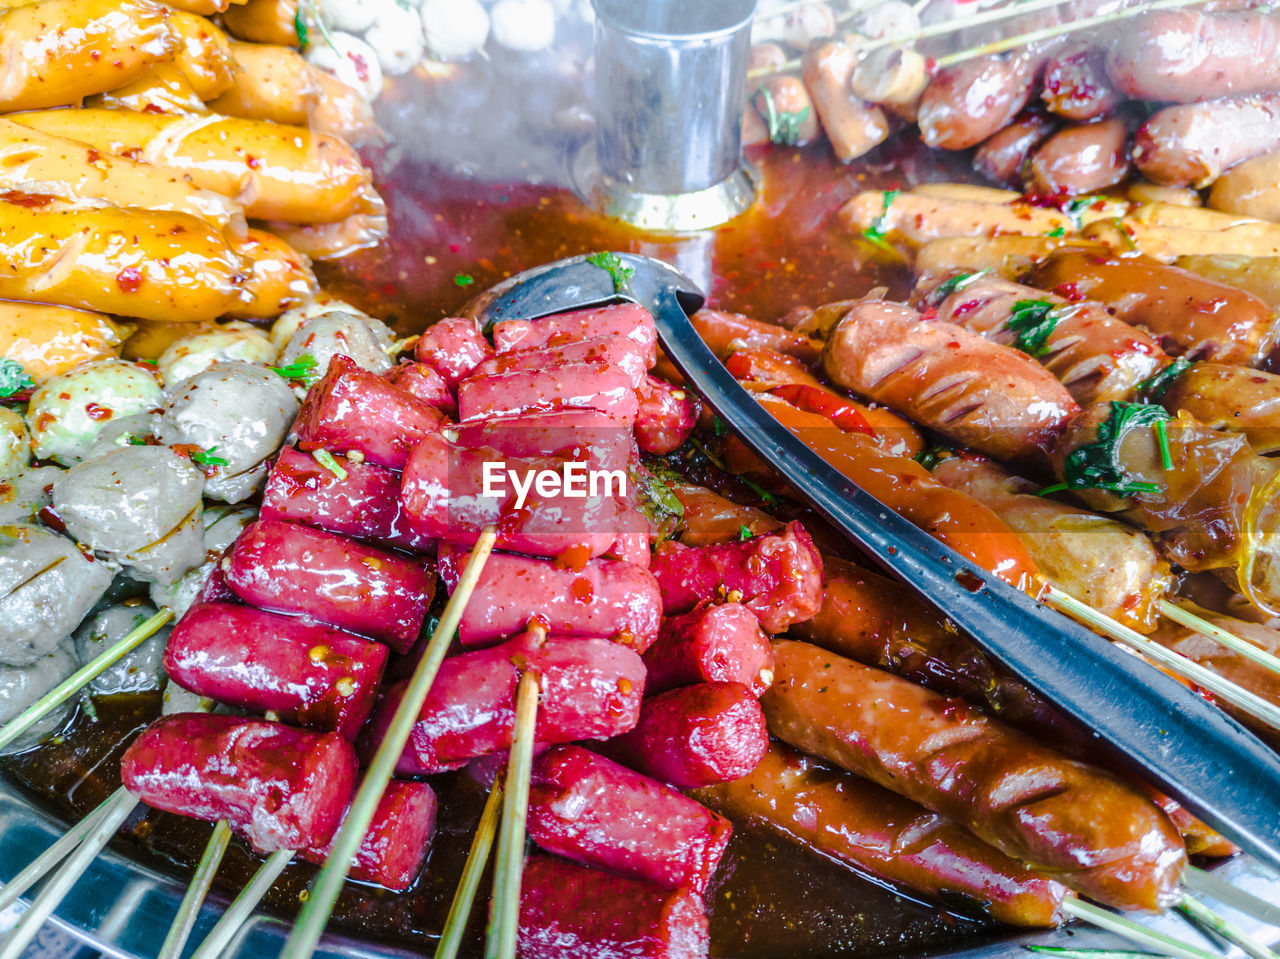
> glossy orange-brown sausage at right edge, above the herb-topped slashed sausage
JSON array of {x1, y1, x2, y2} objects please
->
[{"x1": 1029, "y1": 251, "x2": 1280, "y2": 366}]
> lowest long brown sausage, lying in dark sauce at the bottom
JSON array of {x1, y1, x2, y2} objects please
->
[{"x1": 691, "y1": 743, "x2": 1066, "y2": 927}]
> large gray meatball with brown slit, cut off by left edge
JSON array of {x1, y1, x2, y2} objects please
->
[{"x1": 0, "y1": 522, "x2": 115, "y2": 666}]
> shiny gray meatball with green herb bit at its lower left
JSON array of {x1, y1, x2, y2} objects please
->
[{"x1": 160, "y1": 361, "x2": 298, "y2": 503}]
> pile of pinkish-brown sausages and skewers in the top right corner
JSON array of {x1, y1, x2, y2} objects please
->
[{"x1": 744, "y1": 0, "x2": 1280, "y2": 203}]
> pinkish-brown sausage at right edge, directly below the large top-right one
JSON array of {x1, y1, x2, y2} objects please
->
[{"x1": 1133, "y1": 93, "x2": 1280, "y2": 188}]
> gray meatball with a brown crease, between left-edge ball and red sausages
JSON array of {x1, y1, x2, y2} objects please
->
[{"x1": 54, "y1": 446, "x2": 205, "y2": 583}]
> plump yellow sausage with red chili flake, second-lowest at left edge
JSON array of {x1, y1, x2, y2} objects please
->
[{"x1": 0, "y1": 196, "x2": 248, "y2": 321}]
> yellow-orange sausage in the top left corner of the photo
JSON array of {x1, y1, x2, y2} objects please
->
[{"x1": 0, "y1": 0, "x2": 182, "y2": 111}]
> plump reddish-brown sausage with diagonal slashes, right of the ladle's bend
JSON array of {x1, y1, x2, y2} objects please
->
[{"x1": 823, "y1": 301, "x2": 1079, "y2": 460}]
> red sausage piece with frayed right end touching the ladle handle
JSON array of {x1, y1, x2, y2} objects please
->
[{"x1": 650, "y1": 522, "x2": 822, "y2": 633}]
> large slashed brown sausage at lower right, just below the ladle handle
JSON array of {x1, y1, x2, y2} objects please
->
[{"x1": 762, "y1": 640, "x2": 1187, "y2": 909}]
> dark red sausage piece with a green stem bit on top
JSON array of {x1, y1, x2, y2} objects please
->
[{"x1": 259, "y1": 447, "x2": 435, "y2": 552}]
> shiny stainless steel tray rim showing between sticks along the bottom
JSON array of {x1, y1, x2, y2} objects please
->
[{"x1": 0, "y1": 777, "x2": 1280, "y2": 959}]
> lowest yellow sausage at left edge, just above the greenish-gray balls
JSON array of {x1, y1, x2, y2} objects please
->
[{"x1": 0, "y1": 300, "x2": 131, "y2": 385}]
